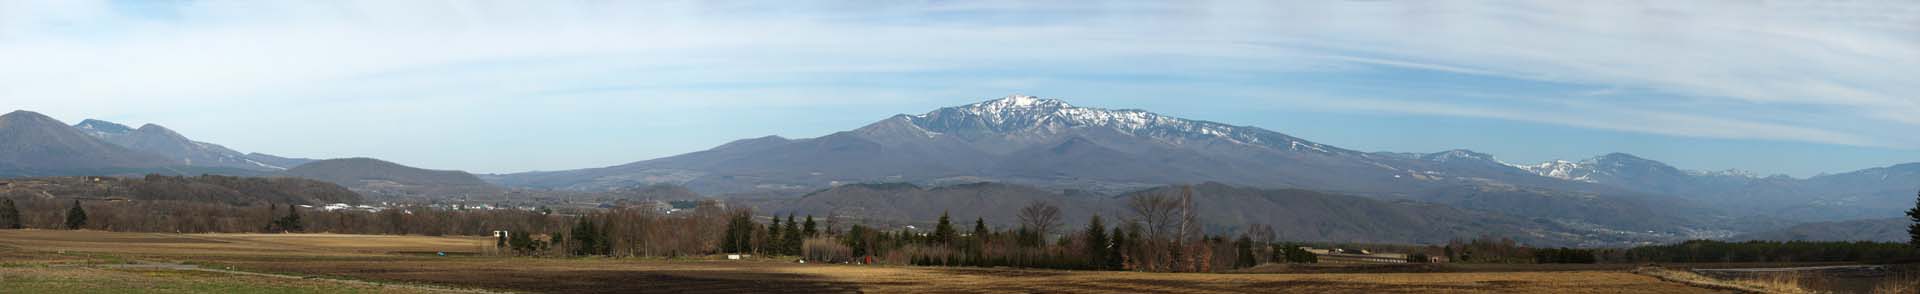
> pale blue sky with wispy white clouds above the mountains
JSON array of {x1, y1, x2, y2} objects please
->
[{"x1": 0, "y1": 0, "x2": 1920, "y2": 177}]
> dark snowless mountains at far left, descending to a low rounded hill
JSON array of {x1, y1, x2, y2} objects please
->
[{"x1": 0, "y1": 111, "x2": 503, "y2": 198}]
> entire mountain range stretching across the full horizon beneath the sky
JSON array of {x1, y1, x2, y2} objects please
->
[{"x1": 0, "y1": 96, "x2": 1920, "y2": 246}]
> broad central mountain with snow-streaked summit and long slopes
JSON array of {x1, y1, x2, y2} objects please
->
[{"x1": 488, "y1": 96, "x2": 1711, "y2": 231}]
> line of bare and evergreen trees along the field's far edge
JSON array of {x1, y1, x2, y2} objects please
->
[{"x1": 0, "y1": 177, "x2": 1920, "y2": 273}]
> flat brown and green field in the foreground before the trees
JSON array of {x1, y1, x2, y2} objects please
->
[{"x1": 0, "y1": 231, "x2": 1715, "y2": 294}]
